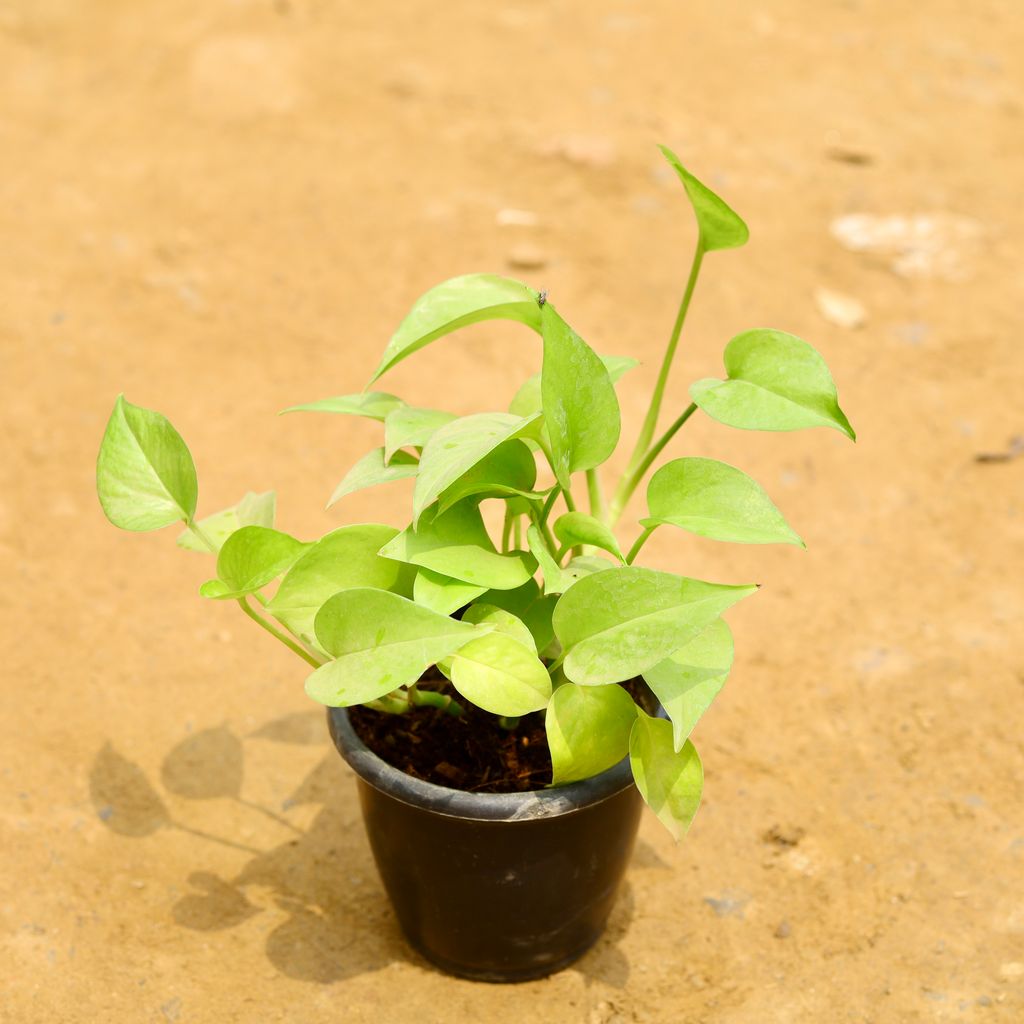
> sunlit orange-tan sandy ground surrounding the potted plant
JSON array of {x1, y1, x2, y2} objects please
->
[{"x1": 0, "y1": 0, "x2": 1024, "y2": 1024}]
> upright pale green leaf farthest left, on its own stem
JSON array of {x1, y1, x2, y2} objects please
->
[{"x1": 96, "y1": 395, "x2": 199, "y2": 530}]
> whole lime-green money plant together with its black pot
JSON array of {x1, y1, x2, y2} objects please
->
[{"x1": 96, "y1": 150, "x2": 854, "y2": 980}]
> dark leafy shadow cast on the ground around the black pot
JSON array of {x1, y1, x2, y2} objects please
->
[{"x1": 89, "y1": 712, "x2": 643, "y2": 988}]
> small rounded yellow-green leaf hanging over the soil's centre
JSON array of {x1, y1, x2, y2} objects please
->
[{"x1": 452, "y1": 630, "x2": 551, "y2": 717}]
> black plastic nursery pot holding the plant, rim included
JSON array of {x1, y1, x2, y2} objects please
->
[{"x1": 328, "y1": 708, "x2": 641, "y2": 981}]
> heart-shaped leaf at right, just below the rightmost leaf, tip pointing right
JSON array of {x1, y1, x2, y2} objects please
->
[{"x1": 643, "y1": 458, "x2": 807, "y2": 548}]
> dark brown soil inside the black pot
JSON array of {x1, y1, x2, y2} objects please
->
[{"x1": 348, "y1": 674, "x2": 649, "y2": 793}]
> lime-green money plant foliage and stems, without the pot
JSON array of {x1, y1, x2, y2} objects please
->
[{"x1": 96, "y1": 147, "x2": 854, "y2": 838}]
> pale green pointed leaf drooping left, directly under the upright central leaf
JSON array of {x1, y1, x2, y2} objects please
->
[{"x1": 413, "y1": 413, "x2": 540, "y2": 523}]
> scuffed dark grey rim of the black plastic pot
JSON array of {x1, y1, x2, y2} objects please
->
[{"x1": 327, "y1": 708, "x2": 633, "y2": 821}]
